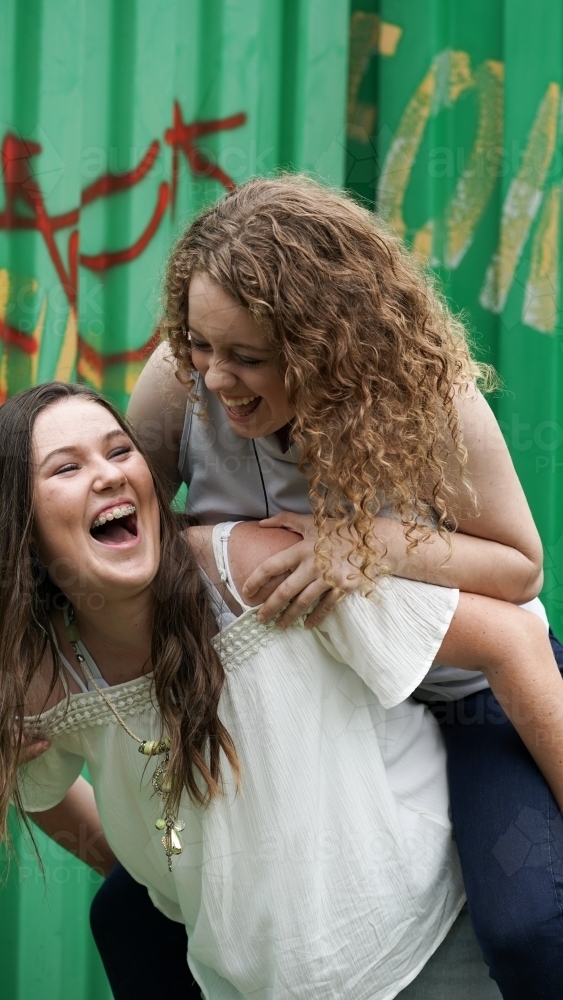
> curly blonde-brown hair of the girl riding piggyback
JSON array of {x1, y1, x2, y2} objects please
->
[{"x1": 163, "y1": 175, "x2": 486, "y2": 580}]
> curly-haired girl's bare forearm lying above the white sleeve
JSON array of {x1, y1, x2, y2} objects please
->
[{"x1": 374, "y1": 517, "x2": 543, "y2": 604}]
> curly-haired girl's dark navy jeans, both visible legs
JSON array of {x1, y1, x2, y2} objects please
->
[{"x1": 91, "y1": 638, "x2": 563, "y2": 1000}]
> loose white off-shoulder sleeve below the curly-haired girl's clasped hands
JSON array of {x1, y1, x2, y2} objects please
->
[{"x1": 314, "y1": 576, "x2": 459, "y2": 708}]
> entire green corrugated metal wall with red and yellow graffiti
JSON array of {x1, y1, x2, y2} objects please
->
[{"x1": 0, "y1": 0, "x2": 563, "y2": 1000}]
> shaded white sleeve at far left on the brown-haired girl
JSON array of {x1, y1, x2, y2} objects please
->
[{"x1": 18, "y1": 746, "x2": 84, "y2": 812}]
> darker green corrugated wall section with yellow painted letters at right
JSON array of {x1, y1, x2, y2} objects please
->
[{"x1": 346, "y1": 0, "x2": 563, "y2": 635}]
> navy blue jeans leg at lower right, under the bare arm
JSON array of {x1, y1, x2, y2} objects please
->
[{"x1": 433, "y1": 637, "x2": 563, "y2": 1000}]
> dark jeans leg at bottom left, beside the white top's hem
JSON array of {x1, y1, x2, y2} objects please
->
[{"x1": 90, "y1": 864, "x2": 201, "y2": 1000}]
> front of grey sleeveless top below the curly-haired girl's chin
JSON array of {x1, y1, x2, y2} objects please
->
[{"x1": 178, "y1": 378, "x2": 311, "y2": 524}]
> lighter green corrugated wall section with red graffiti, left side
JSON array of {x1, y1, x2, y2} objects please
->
[{"x1": 0, "y1": 0, "x2": 349, "y2": 1000}]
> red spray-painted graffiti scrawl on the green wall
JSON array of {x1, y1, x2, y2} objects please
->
[{"x1": 0, "y1": 101, "x2": 246, "y2": 373}]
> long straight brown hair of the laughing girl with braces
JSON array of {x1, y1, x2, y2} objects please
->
[{"x1": 0, "y1": 382, "x2": 238, "y2": 838}]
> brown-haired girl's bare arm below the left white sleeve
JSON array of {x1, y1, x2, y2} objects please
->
[{"x1": 29, "y1": 778, "x2": 116, "y2": 876}]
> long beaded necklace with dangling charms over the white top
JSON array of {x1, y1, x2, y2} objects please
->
[{"x1": 64, "y1": 604, "x2": 185, "y2": 872}]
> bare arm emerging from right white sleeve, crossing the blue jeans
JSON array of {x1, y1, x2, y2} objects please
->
[{"x1": 436, "y1": 594, "x2": 563, "y2": 809}]
